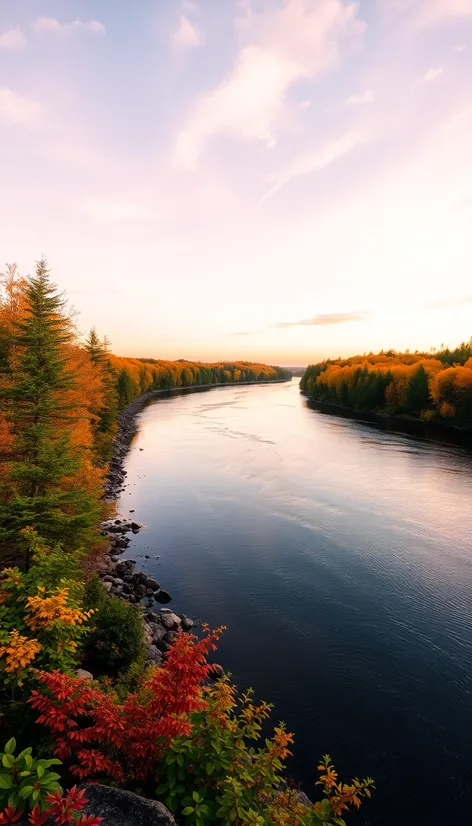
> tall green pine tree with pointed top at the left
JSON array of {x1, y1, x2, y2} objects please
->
[{"x1": 0, "y1": 260, "x2": 99, "y2": 548}]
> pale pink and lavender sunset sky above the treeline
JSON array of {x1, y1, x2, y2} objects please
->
[{"x1": 0, "y1": 0, "x2": 472, "y2": 364}]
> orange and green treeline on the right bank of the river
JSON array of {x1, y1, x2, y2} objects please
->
[{"x1": 300, "y1": 339, "x2": 472, "y2": 430}]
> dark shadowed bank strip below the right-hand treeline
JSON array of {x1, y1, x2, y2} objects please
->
[{"x1": 300, "y1": 390, "x2": 472, "y2": 449}]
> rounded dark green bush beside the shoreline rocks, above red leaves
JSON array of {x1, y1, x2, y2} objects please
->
[{"x1": 84, "y1": 576, "x2": 146, "y2": 677}]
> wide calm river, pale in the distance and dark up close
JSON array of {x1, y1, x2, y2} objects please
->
[{"x1": 120, "y1": 381, "x2": 472, "y2": 826}]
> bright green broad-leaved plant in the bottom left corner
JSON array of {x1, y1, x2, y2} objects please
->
[{"x1": 0, "y1": 737, "x2": 62, "y2": 811}]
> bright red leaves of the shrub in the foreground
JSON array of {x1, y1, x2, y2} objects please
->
[{"x1": 29, "y1": 630, "x2": 224, "y2": 784}]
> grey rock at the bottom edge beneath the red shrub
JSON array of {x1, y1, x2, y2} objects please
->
[{"x1": 82, "y1": 784, "x2": 176, "y2": 826}]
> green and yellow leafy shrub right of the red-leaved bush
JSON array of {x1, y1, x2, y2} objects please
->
[{"x1": 156, "y1": 680, "x2": 373, "y2": 826}]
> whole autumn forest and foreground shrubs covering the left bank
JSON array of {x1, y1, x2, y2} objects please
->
[{"x1": 0, "y1": 261, "x2": 373, "y2": 826}]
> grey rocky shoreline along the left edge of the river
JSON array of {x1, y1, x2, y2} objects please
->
[{"x1": 98, "y1": 393, "x2": 223, "y2": 679}]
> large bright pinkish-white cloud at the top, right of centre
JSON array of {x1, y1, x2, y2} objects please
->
[{"x1": 176, "y1": 0, "x2": 365, "y2": 166}]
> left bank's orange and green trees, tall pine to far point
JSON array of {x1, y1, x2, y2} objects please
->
[{"x1": 0, "y1": 261, "x2": 290, "y2": 551}]
